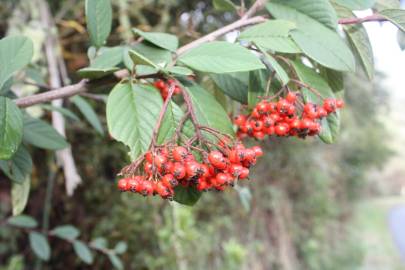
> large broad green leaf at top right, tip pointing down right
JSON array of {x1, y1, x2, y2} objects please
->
[{"x1": 267, "y1": 2, "x2": 355, "y2": 71}]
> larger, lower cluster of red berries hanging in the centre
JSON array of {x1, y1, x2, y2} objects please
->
[{"x1": 118, "y1": 143, "x2": 263, "y2": 199}]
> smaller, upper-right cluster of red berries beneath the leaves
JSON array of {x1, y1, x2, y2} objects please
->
[{"x1": 234, "y1": 92, "x2": 344, "y2": 140}]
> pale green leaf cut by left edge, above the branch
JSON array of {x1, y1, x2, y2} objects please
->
[{"x1": 0, "y1": 36, "x2": 34, "y2": 89}]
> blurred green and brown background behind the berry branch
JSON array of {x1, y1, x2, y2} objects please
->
[{"x1": 0, "y1": 0, "x2": 405, "y2": 270}]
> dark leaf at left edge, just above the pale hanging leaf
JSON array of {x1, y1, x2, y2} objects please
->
[{"x1": 0, "y1": 144, "x2": 32, "y2": 184}]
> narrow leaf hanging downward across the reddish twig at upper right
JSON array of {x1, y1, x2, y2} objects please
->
[{"x1": 336, "y1": 6, "x2": 374, "y2": 80}]
